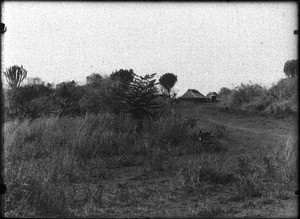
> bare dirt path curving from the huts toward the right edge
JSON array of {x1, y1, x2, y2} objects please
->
[{"x1": 179, "y1": 104, "x2": 296, "y2": 147}]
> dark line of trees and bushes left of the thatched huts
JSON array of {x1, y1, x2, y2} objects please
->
[{"x1": 4, "y1": 65, "x2": 177, "y2": 123}]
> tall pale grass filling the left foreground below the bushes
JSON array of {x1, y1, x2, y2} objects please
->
[{"x1": 4, "y1": 113, "x2": 197, "y2": 216}]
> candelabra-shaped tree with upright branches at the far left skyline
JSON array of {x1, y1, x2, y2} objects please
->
[{"x1": 3, "y1": 65, "x2": 27, "y2": 89}]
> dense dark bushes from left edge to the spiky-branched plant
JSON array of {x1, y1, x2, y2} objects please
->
[{"x1": 4, "y1": 77, "x2": 122, "y2": 120}]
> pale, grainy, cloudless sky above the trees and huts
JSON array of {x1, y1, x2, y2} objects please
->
[{"x1": 1, "y1": 1, "x2": 299, "y2": 95}]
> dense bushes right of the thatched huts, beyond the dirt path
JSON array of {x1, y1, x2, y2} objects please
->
[{"x1": 219, "y1": 78, "x2": 298, "y2": 116}]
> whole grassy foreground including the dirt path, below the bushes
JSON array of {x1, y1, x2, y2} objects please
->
[{"x1": 4, "y1": 104, "x2": 298, "y2": 217}]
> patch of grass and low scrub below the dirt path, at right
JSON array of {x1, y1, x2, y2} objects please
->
[{"x1": 178, "y1": 133, "x2": 299, "y2": 201}]
